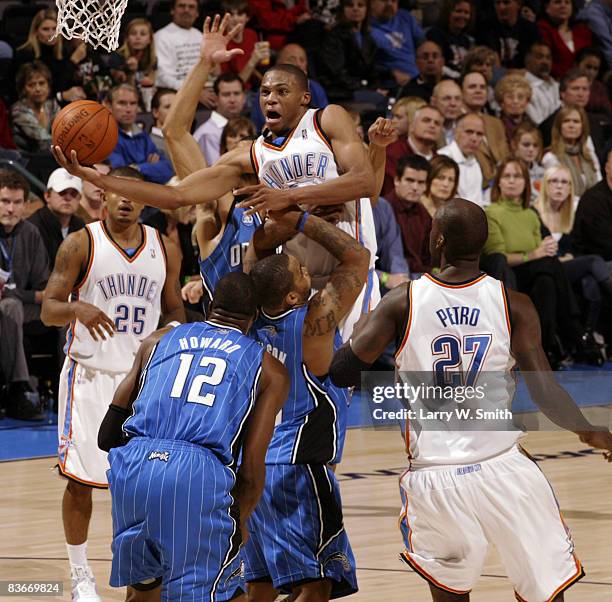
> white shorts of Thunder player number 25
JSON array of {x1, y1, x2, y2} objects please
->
[{"x1": 57, "y1": 357, "x2": 125, "y2": 488}]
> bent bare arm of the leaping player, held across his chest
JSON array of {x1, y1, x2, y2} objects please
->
[{"x1": 237, "y1": 105, "x2": 376, "y2": 213}]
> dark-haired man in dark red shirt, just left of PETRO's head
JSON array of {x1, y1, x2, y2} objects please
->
[{"x1": 385, "y1": 155, "x2": 431, "y2": 277}]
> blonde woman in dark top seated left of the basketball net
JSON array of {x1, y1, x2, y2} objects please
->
[{"x1": 14, "y1": 8, "x2": 85, "y2": 102}]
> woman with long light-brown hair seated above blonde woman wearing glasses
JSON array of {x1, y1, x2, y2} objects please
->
[{"x1": 542, "y1": 105, "x2": 601, "y2": 196}]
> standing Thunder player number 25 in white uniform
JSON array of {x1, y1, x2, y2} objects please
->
[{"x1": 41, "y1": 167, "x2": 185, "y2": 600}]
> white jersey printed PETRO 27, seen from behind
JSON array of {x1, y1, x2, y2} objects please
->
[{"x1": 396, "y1": 274, "x2": 522, "y2": 468}]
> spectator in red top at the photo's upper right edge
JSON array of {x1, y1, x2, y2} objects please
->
[{"x1": 538, "y1": 0, "x2": 593, "y2": 79}]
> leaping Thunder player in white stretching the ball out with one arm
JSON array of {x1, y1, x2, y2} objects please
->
[{"x1": 53, "y1": 14, "x2": 379, "y2": 334}]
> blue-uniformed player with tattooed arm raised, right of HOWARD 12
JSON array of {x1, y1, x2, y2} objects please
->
[{"x1": 244, "y1": 211, "x2": 369, "y2": 602}]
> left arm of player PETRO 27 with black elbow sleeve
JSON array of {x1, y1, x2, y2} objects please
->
[{"x1": 329, "y1": 284, "x2": 410, "y2": 387}]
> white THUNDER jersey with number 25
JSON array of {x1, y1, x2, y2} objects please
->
[{"x1": 67, "y1": 221, "x2": 166, "y2": 373}]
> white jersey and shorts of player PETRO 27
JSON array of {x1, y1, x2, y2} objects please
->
[{"x1": 396, "y1": 274, "x2": 584, "y2": 602}]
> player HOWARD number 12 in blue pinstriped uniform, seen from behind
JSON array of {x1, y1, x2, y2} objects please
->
[{"x1": 98, "y1": 272, "x2": 289, "y2": 602}]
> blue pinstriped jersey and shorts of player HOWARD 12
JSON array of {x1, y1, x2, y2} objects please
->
[{"x1": 108, "y1": 321, "x2": 264, "y2": 602}]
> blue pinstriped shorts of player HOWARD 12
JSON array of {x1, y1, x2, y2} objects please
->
[{"x1": 108, "y1": 437, "x2": 245, "y2": 602}]
